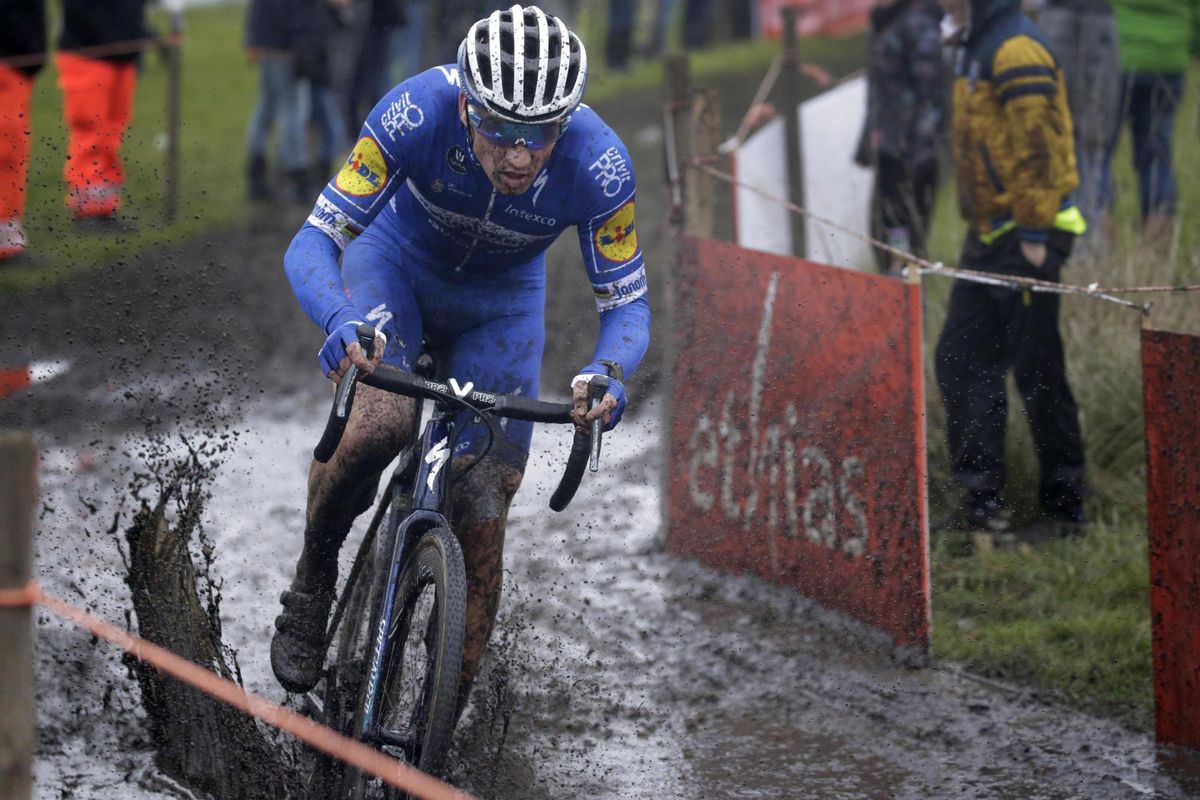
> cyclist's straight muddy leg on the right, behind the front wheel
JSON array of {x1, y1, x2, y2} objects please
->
[{"x1": 454, "y1": 458, "x2": 522, "y2": 714}]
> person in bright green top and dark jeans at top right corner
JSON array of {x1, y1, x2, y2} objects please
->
[{"x1": 1108, "y1": 0, "x2": 1198, "y2": 236}]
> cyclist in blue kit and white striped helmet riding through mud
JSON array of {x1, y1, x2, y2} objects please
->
[{"x1": 271, "y1": 6, "x2": 650, "y2": 710}]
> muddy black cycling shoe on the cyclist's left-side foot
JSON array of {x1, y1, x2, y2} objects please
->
[{"x1": 271, "y1": 589, "x2": 334, "y2": 694}]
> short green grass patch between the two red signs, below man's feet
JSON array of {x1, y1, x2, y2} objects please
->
[{"x1": 932, "y1": 517, "x2": 1153, "y2": 730}]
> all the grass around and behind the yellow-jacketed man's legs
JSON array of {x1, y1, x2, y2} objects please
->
[{"x1": 925, "y1": 65, "x2": 1200, "y2": 732}]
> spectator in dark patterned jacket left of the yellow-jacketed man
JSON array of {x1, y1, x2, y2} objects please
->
[{"x1": 857, "y1": 0, "x2": 946, "y2": 273}]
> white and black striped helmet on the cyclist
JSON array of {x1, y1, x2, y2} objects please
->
[{"x1": 458, "y1": 6, "x2": 588, "y2": 122}]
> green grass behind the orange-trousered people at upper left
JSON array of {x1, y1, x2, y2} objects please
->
[{"x1": 0, "y1": 5, "x2": 256, "y2": 293}]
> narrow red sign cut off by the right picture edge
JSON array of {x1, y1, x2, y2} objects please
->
[{"x1": 1141, "y1": 331, "x2": 1200, "y2": 748}]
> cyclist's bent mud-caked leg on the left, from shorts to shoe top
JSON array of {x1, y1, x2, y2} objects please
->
[{"x1": 295, "y1": 384, "x2": 414, "y2": 590}]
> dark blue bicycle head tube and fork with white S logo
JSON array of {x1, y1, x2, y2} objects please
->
[{"x1": 356, "y1": 403, "x2": 457, "y2": 746}]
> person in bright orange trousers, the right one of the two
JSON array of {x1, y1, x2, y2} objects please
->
[{"x1": 58, "y1": 0, "x2": 146, "y2": 230}]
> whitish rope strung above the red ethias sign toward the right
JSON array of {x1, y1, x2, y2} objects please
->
[{"x1": 688, "y1": 156, "x2": 1176, "y2": 315}]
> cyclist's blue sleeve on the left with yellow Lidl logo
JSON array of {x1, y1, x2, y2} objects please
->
[{"x1": 283, "y1": 71, "x2": 441, "y2": 333}]
